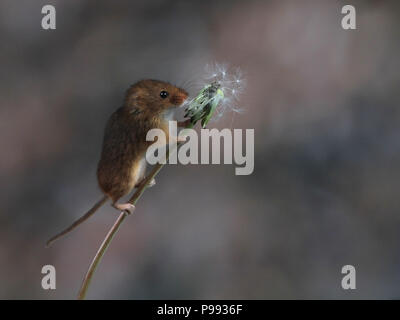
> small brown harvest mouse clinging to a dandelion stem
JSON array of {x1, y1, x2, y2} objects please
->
[{"x1": 47, "y1": 80, "x2": 188, "y2": 246}]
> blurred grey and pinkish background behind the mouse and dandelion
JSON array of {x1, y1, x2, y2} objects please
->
[{"x1": 0, "y1": 0, "x2": 400, "y2": 299}]
